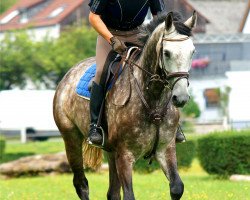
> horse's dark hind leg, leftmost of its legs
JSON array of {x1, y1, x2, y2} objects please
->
[{"x1": 61, "y1": 128, "x2": 89, "y2": 200}]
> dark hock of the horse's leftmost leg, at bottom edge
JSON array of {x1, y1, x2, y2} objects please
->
[{"x1": 73, "y1": 175, "x2": 89, "y2": 200}]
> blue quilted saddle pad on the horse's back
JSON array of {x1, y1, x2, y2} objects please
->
[{"x1": 76, "y1": 64, "x2": 122, "y2": 99}]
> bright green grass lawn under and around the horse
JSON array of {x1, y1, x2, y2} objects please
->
[{"x1": 0, "y1": 140, "x2": 250, "y2": 200}]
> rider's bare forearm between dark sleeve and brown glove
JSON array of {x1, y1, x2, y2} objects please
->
[{"x1": 89, "y1": 11, "x2": 113, "y2": 43}]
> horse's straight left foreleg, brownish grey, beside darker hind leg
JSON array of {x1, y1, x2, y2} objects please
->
[{"x1": 115, "y1": 151, "x2": 135, "y2": 200}]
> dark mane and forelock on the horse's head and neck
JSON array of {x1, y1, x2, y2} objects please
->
[{"x1": 140, "y1": 12, "x2": 192, "y2": 44}]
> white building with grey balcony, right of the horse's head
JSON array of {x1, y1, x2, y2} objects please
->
[{"x1": 190, "y1": 34, "x2": 250, "y2": 129}]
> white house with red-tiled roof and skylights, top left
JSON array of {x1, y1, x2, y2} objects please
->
[{"x1": 0, "y1": 0, "x2": 88, "y2": 41}]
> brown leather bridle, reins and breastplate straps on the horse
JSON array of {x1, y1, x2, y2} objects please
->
[{"x1": 124, "y1": 36, "x2": 189, "y2": 164}]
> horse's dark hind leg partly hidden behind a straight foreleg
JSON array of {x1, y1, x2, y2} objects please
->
[{"x1": 107, "y1": 153, "x2": 121, "y2": 200}]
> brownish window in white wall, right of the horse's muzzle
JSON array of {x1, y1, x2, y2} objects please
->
[{"x1": 204, "y1": 88, "x2": 220, "y2": 108}]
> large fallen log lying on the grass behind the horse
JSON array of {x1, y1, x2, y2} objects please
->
[{"x1": 0, "y1": 153, "x2": 71, "y2": 177}]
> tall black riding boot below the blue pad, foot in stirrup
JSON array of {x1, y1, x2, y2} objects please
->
[{"x1": 88, "y1": 81, "x2": 104, "y2": 146}]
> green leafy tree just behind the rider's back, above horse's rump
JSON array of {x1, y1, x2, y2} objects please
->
[{"x1": 50, "y1": 27, "x2": 97, "y2": 84}]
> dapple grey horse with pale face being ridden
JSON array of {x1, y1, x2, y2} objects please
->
[{"x1": 54, "y1": 12, "x2": 197, "y2": 200}]
